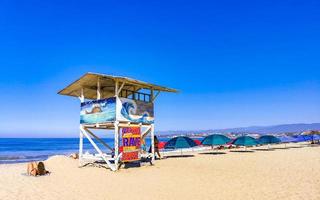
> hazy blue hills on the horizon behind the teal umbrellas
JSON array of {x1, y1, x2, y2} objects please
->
[{"x1": 158, "y1": 123, "x2": 320, "y2": 135}]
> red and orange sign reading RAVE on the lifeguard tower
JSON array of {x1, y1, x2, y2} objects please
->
[{"x1": 122, "y1": 127, "x2": 141, "y2": 162}]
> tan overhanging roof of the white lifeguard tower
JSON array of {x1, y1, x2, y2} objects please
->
[{"x1": 58, "y1": 72, "x2": 178, "y2": 99}]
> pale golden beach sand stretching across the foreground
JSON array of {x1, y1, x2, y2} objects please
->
[{"x1": 0, "y1": 144, "x2": 320, "y2": 200}]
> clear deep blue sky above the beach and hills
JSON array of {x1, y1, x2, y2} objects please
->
[{"x1": 0, "y1": 0, "x2": 320, "y2": 137}]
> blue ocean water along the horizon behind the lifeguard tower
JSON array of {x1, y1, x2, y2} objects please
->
[{"x1": 0, "y1": 138, "x2": 166, "y2": 164}]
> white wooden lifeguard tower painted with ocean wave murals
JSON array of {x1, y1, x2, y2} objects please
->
[{"x1": 58, "y1": 73, "x2": 177, "y2": 171}]
